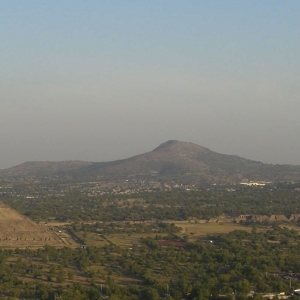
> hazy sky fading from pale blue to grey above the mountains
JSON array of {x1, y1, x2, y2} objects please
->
[{"x1": 0, "y1": 0, "x2": 300, "y2": 168}]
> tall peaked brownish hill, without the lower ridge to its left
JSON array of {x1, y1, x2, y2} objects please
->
[{"x1": 62, "y1": 140, "x2": 300, "y2": 183}]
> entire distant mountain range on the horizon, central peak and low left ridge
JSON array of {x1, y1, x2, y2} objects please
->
[{"x1": 0, "y1": 140, "x2": 300, "y2": 184}]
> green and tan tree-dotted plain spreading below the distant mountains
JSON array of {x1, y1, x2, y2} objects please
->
[{"x1": 0, "y1": 180, "x2": 300, "y2": 300}]
